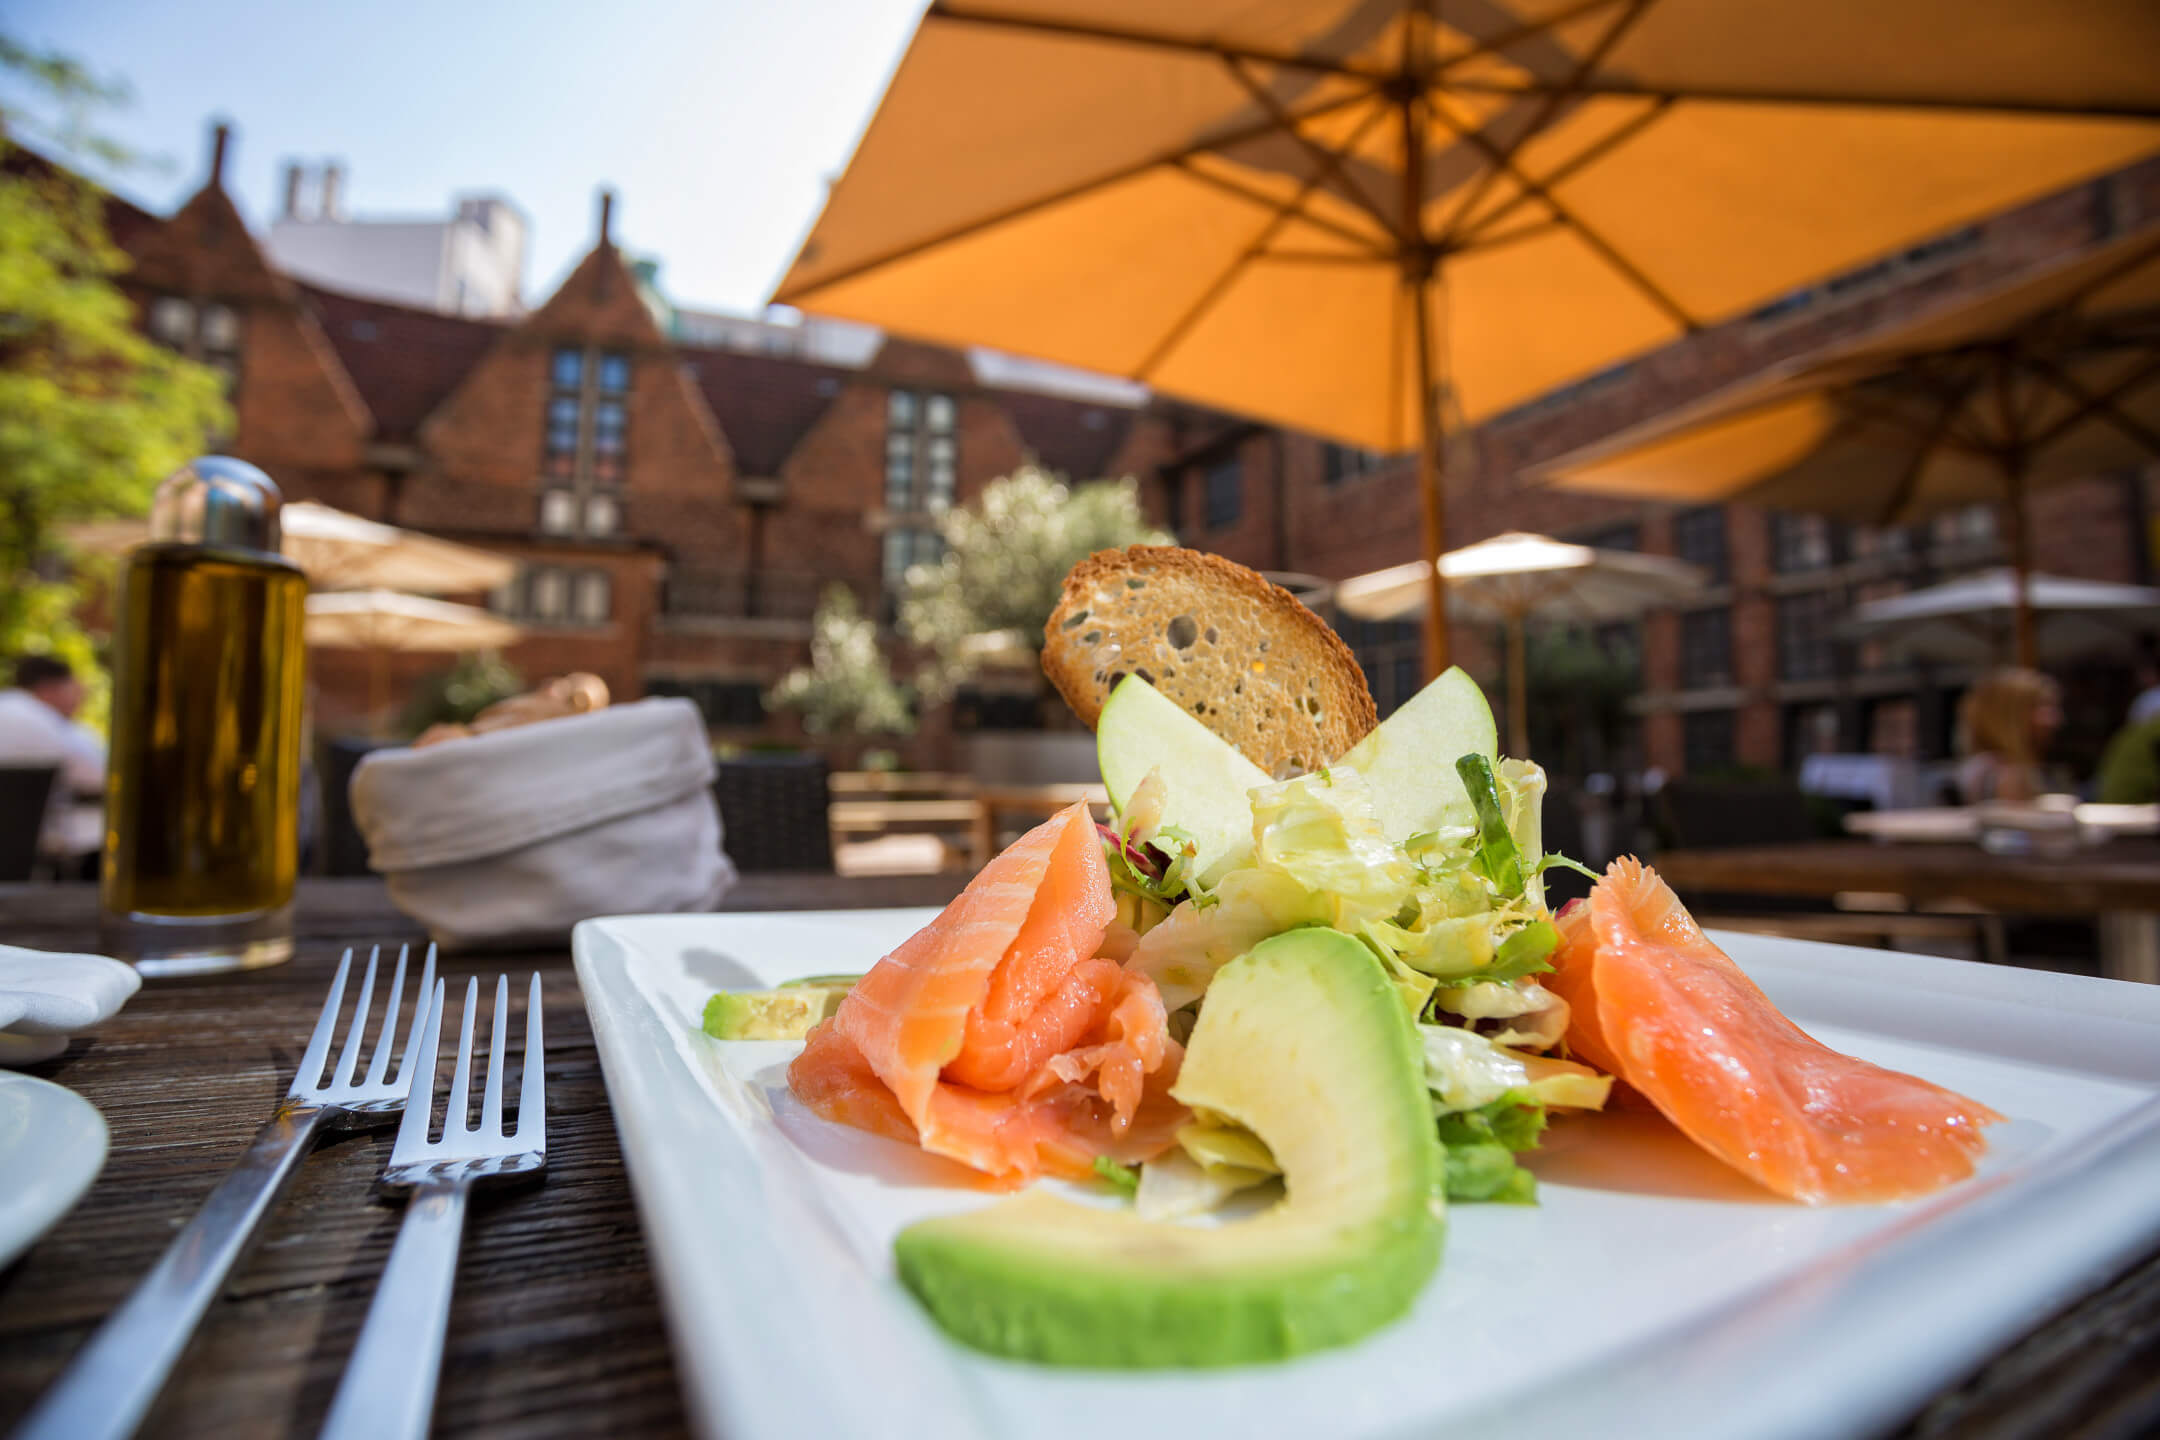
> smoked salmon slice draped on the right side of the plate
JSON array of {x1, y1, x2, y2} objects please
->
[{"x1": 1544, "y1": 857, "x2": 2002, "y2": 1205}]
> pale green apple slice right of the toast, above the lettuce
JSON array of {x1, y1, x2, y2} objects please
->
[{"x1": 1337, "y1": 665, "x2": 1499, "y2": 844}]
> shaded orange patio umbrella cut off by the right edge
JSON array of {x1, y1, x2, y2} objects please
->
[{"x1": 1534, "y1": 227, "x2": 2160, "y2": 667}]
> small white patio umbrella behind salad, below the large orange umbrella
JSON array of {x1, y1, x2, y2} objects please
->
[{"x1": 1335, "y1": 531, "x2": 1709, "y2": 756}]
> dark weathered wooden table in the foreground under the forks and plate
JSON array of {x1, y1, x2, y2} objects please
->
[{"x1": 0, "y1": 874, "x2": 2160, "y2": 1440}]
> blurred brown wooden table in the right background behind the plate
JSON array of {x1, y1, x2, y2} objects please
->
[{"x1": 1657, "y1": 840, "x2": 2160, "y2": 984}]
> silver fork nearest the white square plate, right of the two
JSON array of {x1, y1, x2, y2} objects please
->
[{"x1": 322, "y1": 976, "x2": 546, "y2": 1440}]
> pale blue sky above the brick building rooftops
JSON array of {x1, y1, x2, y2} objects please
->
[{"x1": 0, "y1": 0, "x2": 922, "y2": 311}]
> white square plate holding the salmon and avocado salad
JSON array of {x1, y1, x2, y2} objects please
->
[{"x1": 572, "y1": 909, "x2": 2160, "y2": 1440}]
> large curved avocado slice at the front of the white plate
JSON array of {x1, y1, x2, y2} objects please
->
[{"x1": 894, "y1": 928, "x2": 1445, "y2": 1367}]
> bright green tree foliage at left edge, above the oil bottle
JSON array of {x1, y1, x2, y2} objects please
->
[{"x1": 0, "y1": 41, "x2": 231, "y2": 716}]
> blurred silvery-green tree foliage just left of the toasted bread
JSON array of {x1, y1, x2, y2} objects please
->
[{"x1": 901, "y1": 466, "x2": 1171, "y2": 695}]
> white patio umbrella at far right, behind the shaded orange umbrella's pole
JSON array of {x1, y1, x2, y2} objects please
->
[{"x1": 1842, "y1": 566, "x2": 2160, "y2": 665}]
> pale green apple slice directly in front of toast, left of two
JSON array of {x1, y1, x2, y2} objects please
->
[{"x1": 1095, "y1": 676, "x2": 1268, "y2": 885}]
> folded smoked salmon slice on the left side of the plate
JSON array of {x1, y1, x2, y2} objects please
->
[{"x1": 788, "y1": 805, "x2": 1186, "y2": 1185}]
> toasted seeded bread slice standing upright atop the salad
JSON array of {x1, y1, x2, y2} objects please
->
[{"x1": 1043, "y1": 544, "x2": 1378, "y2": 777}]
